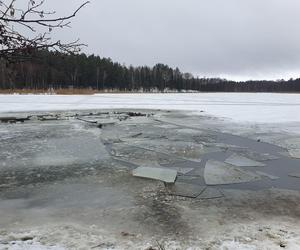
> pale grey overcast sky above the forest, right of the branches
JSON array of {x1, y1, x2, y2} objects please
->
[{"x1": 47, "y1": 0, "x2": 300, "y2": 79}]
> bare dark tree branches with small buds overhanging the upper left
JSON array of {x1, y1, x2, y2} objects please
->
[{"x1": 0, "y1": 0, "x2": 89, "y2": 61}]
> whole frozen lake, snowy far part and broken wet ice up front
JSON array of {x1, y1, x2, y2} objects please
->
[{"x1": 0, "y1": 94, "x2": 300, "y2": 250}]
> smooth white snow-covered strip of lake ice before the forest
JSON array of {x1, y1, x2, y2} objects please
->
[{"x1": 0, "y1": 93, "x2": 300, "y2": 123}]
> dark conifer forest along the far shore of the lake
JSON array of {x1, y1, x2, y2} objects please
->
[{"x1": 0, "y1": 50, "x2": 300, "y2": 92}]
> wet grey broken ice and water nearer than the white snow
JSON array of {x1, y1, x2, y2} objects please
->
[{"x1": 0, "y1": 110, "x2": 300, "y2": 249}]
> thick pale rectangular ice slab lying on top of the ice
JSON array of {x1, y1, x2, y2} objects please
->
[{"x1": 132, "y1": 167, "x2": 177, "y2": 183}]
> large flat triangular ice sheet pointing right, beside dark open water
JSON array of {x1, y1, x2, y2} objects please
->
[{"x1": 204, "y1": 160, "x2": 261, "y2": 185}]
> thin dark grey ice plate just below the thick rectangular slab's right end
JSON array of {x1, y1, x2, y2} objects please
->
[{"x1": 168, "y1": 182, "x2": 205, "y2": 198}]
